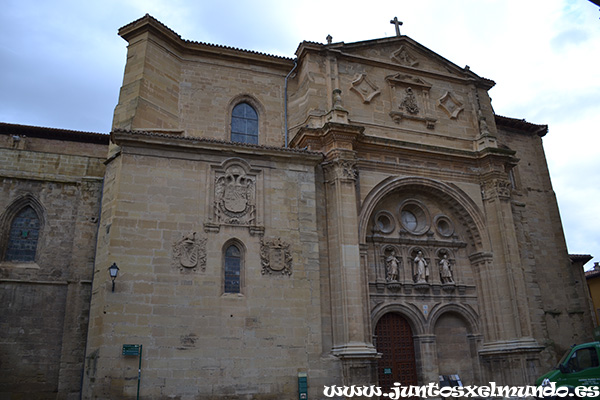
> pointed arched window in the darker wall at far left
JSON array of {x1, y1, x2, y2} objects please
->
[{"x1": 4, "y1": 206, "x2": 40, "y2": 262}]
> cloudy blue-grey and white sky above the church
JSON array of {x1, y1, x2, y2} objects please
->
[{"x1": 0, "y1": 0, "x2": 600, "y2": 269}]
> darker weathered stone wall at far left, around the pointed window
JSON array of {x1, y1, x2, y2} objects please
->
[{"x1": 0, "y1": 125, "x2": 108, "y2": 399}]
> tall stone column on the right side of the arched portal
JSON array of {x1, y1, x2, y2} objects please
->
[{"x1": 471, "y1": 168, "x2": 543, "y2": 385}]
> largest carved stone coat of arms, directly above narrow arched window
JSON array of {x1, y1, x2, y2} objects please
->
[{"x1": 215, "y1": 165, "x2": 256, "y2": 225}]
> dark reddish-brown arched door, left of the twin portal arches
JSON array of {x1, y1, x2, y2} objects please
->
[{"x1": 375, "y1": 313, "x2": 417, "y2": 389}]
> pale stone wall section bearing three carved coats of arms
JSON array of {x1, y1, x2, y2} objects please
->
[{"x1": 84, "y1": 132, "x2": 335, "y2": 399}]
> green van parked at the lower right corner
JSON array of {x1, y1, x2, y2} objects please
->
[{"x1": 535, "y1": 342, "x2": 600, "y2": 399}]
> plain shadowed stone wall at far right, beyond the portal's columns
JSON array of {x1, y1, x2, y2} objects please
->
[{"x1": 498, "y1": 122, "x2": 592, "y2": 370}]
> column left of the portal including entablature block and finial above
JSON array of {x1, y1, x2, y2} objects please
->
[{"x1": 301, "y1": 103, "x2": 378, "y2": 385}]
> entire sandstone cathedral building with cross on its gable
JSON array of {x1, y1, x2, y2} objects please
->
[{"x1": 0, "y1": 15, "x2": 592, "y2": 400}]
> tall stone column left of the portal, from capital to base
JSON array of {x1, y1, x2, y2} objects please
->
[{"x1": 323, "y1": 151, "x2": 377, "y2": 385}]
